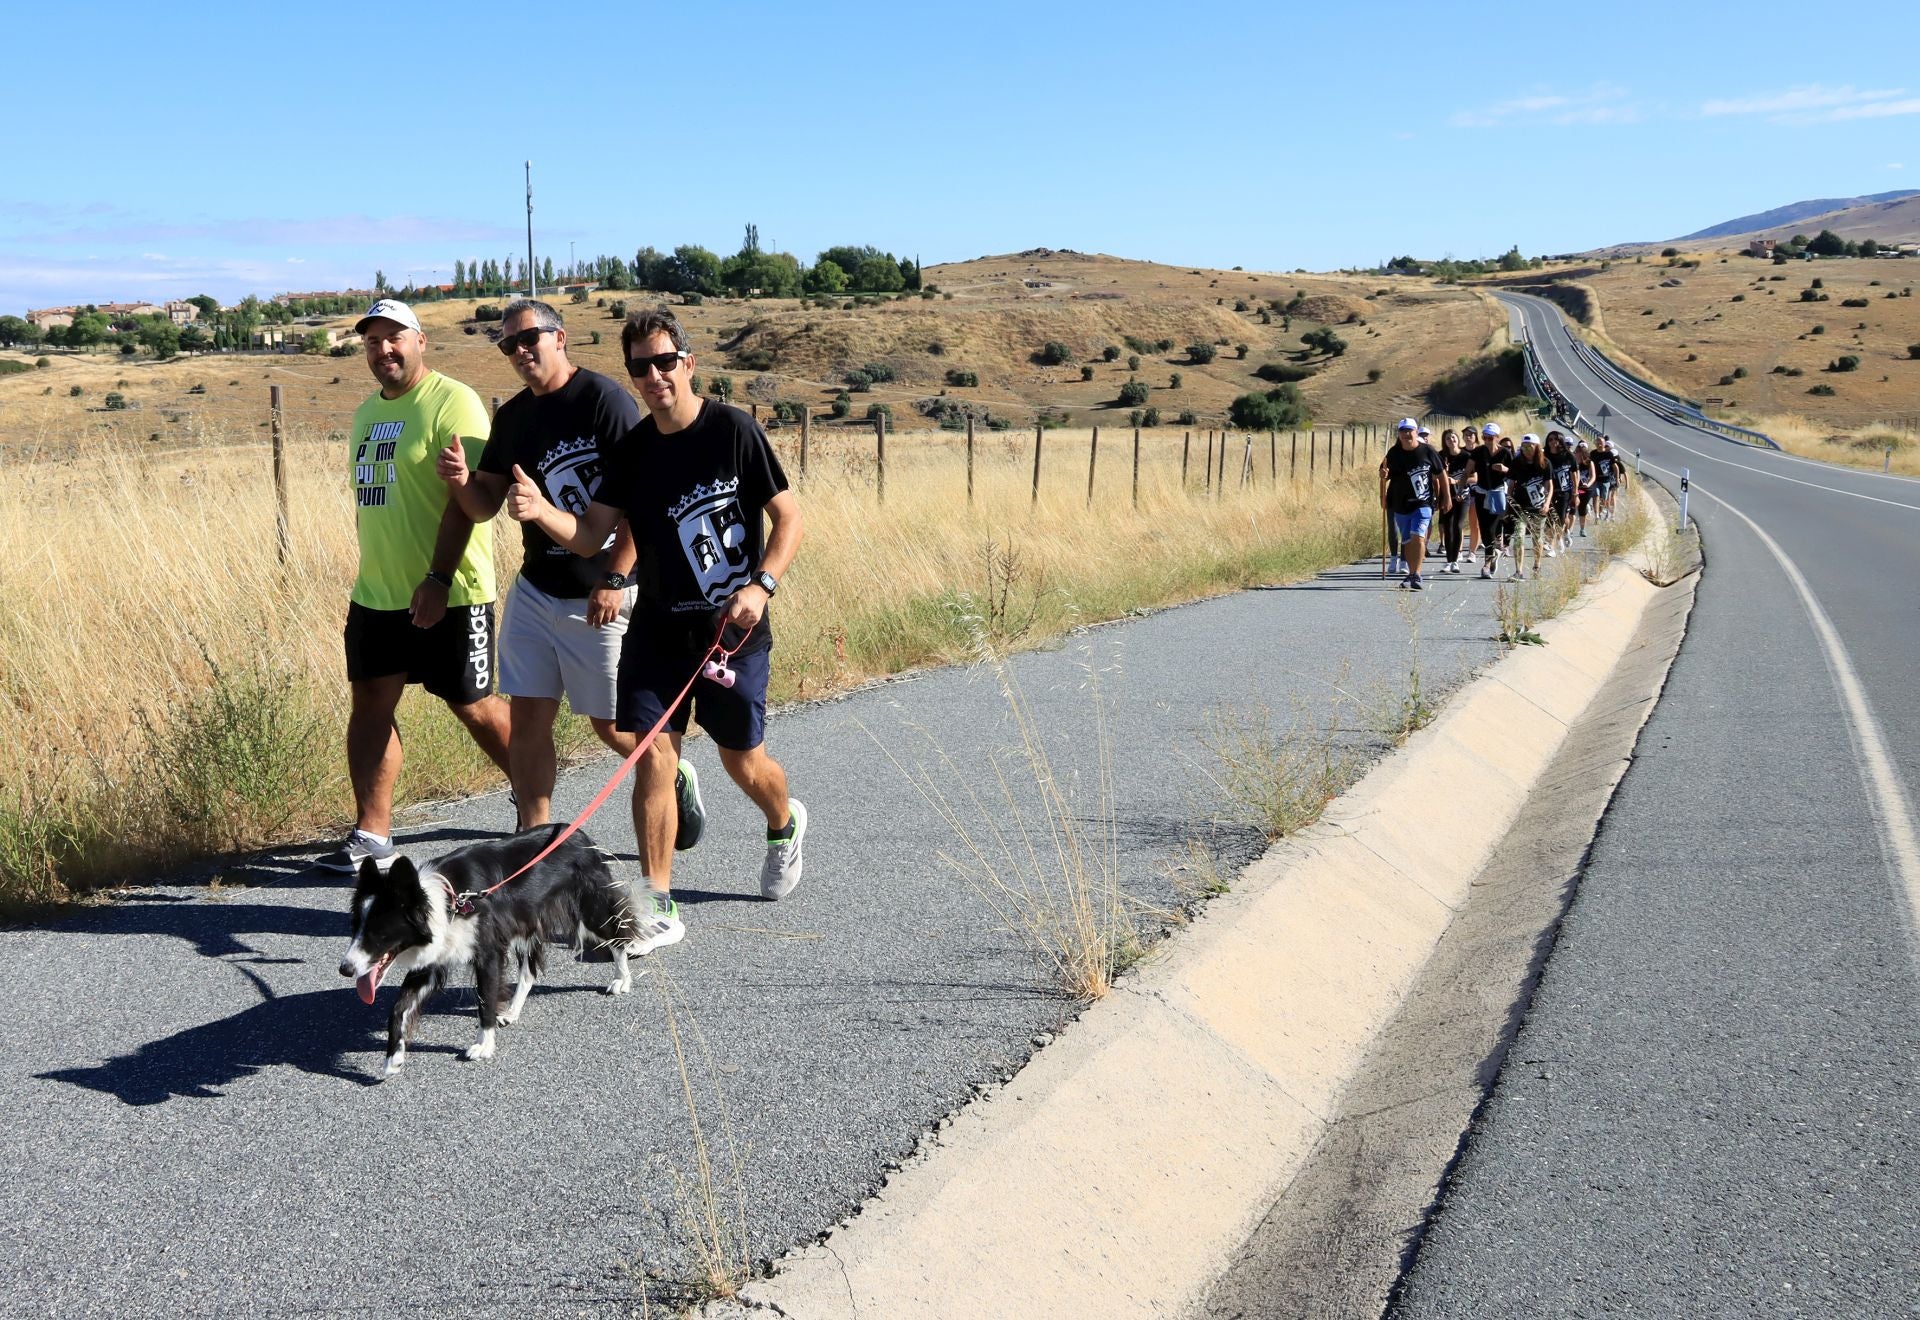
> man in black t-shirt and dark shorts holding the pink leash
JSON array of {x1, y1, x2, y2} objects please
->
[{"x1": 507, "y1": 309, "x2": 806, "y2": 954}]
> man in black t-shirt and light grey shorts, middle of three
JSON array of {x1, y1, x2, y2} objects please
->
[{"x1": 438, "y1": 297, "x2": 701, "y2": 846}]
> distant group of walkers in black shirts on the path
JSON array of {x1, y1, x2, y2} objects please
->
[{"x1": 1380, "y1": 416, "x2": 1626, "y2": 591}]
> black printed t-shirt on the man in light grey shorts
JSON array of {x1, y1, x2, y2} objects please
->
[{"x1": 480, "y1": 368, "x2": 639, "y2": 601}]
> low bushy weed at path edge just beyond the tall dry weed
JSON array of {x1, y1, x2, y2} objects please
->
[{"x1": 1202, "y1": 695, "x2": 1365, "y2": 840}]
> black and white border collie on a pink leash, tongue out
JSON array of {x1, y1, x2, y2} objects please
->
[{"x1": 340, "y1": 825, "x2": 637, "y2": 1076}]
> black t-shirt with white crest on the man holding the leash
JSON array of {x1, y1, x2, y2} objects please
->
[{"x1": 599, "y1": 399, "x2": 787, "y2": 650}]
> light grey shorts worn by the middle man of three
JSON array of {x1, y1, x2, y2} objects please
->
[{"x1": 499, "y1": 578, "x2": 637, "y2": 719}]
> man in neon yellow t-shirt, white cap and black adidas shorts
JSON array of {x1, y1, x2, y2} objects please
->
[{"x1": 319, "y1": 297, "x2": 507, "y2": 871}]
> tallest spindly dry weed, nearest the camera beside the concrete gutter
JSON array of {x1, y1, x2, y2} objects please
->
[{"x1": 868, "y1": 637, "x2": 1150, "y2": 1002}]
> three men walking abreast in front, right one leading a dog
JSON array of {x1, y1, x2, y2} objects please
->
[{"x1": 321, "y1": 299, "x2": 806, "y2": 954}]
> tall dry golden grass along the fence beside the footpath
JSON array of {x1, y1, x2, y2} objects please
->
[{"x1": 0, "y1": 418, "x2": 1377, "y2": 900}]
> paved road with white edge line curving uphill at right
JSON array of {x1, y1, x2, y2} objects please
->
[{"x1": 1390, "y1": 295, "x2": 1920, "y2": 1318}]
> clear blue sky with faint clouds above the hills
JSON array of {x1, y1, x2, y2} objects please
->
[{"x1": 0, "y1": 0, "x2": 1920, "y2": 313}]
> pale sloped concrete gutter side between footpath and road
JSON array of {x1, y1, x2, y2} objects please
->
[{"x1": 714, "y1": 541, "x2": 1657, "y2": 1320}]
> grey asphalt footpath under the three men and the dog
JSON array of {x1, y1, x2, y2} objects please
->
[{"x1": 0, "y1": 533, "x2": 1528, "y2": 1318}]
